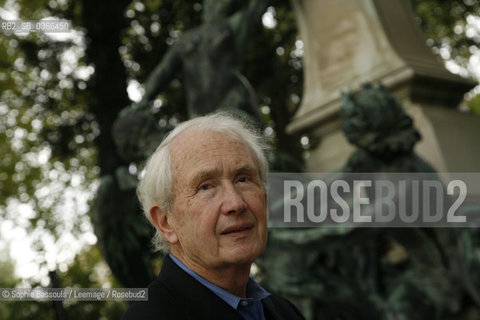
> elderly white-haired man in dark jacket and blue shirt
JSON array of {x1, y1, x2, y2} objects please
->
[{"x1": 124, "y1": 114, "x2": 303, "y2": 320}]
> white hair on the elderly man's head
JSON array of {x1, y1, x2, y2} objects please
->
[{"x1": 137, "y1": 112, "x2": 269, "y2": 253}]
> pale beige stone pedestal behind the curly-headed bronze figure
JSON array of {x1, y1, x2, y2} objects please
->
[{"x1": 288, "y1": 0, "x2": 480, "y2": 172}]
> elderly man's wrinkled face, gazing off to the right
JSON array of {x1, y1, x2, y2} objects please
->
[{"x1": 169, "y1": 131, "x2": 267, "y2": 270}]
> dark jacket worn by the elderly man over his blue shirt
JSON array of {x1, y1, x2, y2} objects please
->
[{"x1": 122, "y1": 256, "x2": 304, "y2": 320}]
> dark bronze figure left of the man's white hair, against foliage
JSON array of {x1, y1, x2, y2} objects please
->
[{"x1": 93, "y1": 107, "x2": 169, "y2": 288}]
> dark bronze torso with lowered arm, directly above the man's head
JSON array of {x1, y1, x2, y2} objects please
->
[{"x1": 134, "y1": 0, "x2": 268, "y2": 119}]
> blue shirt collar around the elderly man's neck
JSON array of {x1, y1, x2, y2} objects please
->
[{"x1": 169, "y1": 253, "x2": 270, "y2": 310}]
